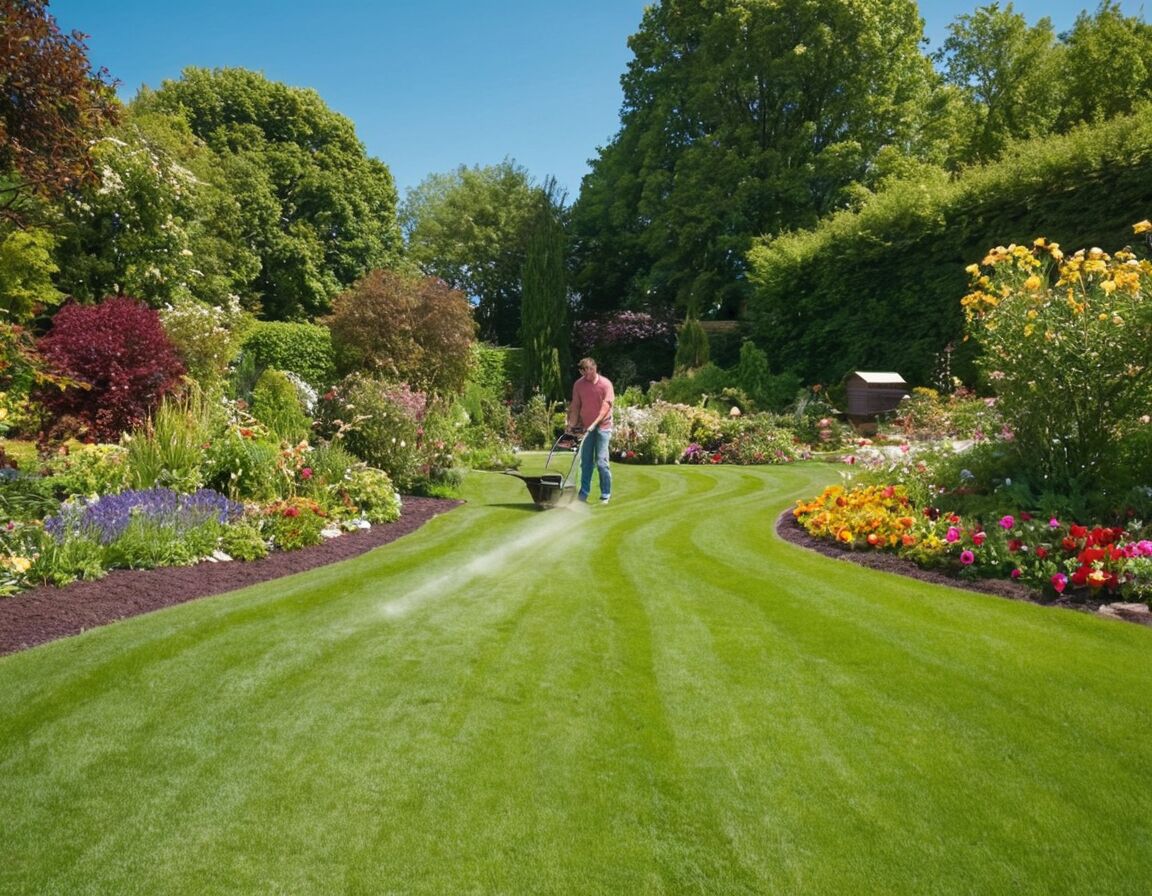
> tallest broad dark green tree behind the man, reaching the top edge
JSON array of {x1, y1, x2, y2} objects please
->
[{"x1": 574, "y1": 0, "x2": 933, "y2": 317}]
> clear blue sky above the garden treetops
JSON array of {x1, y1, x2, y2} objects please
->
[{"x1": 48, "y1": 0, "x2": 1143, "y2": 199}]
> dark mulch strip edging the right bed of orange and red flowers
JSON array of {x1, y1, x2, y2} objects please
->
[{"x1": 776, "y1": 510, "x2": 1152, "y2": 625}]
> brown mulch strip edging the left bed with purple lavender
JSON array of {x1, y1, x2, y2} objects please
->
[{"x1": 0, "y1": 496, "x2": 463, "y2": 655}]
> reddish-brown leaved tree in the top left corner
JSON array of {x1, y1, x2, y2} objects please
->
[{"x1": 0, "y1": 0, "x2": 116, "y2": 219}]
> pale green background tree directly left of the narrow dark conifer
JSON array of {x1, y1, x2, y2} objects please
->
[{"x1": 402, "y1": 159, "x2": 537, "y2": 346}]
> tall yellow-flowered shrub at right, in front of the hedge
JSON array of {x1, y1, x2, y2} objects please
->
[{"x1": 962, "y1": 221, "x2": 1152, "y2": 491}]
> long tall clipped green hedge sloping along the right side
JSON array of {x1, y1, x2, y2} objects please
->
[{"x1": 748, "y1": 106, "x2": 1152, "y2": 385}]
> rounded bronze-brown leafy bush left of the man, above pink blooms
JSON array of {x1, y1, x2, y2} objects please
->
[{"x1": 324, "y1": 271, "x2": 476, "y2": 395}]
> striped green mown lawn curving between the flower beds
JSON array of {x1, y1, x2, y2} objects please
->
[{"x1": 0, "y1": 465, "x2": 1152, "y2": 896}]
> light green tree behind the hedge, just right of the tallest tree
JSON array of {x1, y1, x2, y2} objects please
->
[{"x1": 934, "y1": 2, "x2": 1062, "y2": 164}]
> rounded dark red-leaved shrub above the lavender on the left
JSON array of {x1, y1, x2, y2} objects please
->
[{"x1": 37, "y1": 296, "x2": 184, "y2": 441}]
